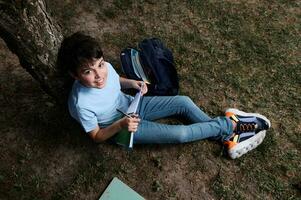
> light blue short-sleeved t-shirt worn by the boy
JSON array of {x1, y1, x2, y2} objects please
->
[{"x1": 68, "y1": 62, "x2": 133, "y2": 132}]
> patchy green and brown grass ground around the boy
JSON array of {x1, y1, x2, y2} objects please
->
[{"x1": 0, "y1": 0, "x2": 301, "y2": 199}]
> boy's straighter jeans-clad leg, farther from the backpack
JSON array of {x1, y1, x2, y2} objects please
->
[{"x1": 134, "y1": 117, "x2": 233, "y2": 143}]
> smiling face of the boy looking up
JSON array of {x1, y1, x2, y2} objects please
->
[{"x1": 73, "y1": 57, "x2": 108, "y2": 89}]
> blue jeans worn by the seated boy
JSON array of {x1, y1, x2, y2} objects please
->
[{"x1": 134, "y1": 96, "x2": 233, "y2": 143}]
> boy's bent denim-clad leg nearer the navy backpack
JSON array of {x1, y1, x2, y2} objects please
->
[{"x1": 139, "y1": 96, "x2": 211, "y2": 123}]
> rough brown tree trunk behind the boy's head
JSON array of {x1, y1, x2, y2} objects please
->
[{"x1": 0, "y1": 0, "x2": 70, "y2": 103}]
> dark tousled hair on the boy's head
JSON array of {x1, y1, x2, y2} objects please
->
[{"x1": 57, "y1": 32, "x2": 103, "y2": 75}]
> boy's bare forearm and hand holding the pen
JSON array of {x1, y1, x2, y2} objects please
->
[{"x1": 89, "y1": 117, "x2": 140, "y2": 142}]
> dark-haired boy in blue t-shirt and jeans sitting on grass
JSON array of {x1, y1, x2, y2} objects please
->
[{"x1": 58, "y1": 32, "x2": 271, "y2": 159}]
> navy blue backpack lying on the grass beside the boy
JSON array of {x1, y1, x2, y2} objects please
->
[{"x1": 120, "y1": 38, "x2": 179, "y2": 96}]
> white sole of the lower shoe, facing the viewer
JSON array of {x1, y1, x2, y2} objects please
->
[{"x1": 228, "y1": 130, "x2": 266, "y2": 159}]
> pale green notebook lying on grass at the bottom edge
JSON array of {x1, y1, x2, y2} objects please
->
[{"x1": 99, "y1": 177, "x2": 145, "y2": 200}]
